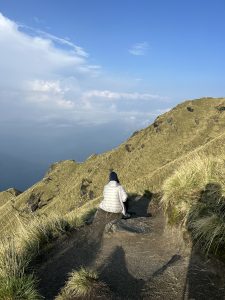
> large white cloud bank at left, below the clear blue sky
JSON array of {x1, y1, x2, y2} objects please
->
[{"x1": 0, "y1": 14, "x2": 169, "y2": 127}]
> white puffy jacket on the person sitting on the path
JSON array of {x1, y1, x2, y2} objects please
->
[{"x1": 99, "y1": 181, "x2": 127, "y2": 215}]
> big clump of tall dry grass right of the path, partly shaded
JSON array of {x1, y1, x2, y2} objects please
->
[{"x1": 162, "y1": 155, "x2": 225, "y2": 253}]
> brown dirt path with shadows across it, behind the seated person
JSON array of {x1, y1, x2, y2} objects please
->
[{"x1": 38, "y1": 196, "x2": 225, "y2": 300}]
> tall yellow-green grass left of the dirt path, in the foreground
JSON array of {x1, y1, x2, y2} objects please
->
[{"x1": 0, "y1": 208, "x2": 96, "y2": 300}]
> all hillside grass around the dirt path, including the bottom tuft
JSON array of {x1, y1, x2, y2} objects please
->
[{"x1": 0, "y1": 98, "x2": 225, "y2": 299}]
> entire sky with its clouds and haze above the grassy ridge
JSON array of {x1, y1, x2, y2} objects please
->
[{"x1": 0, "y1": 0, "x2": 225, "y2": 189}]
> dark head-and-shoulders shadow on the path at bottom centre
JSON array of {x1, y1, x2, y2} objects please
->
[{"x1": 98, "y1": 246, "x2": 145, "y2": 300}]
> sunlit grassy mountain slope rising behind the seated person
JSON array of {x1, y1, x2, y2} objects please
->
[{"x1": 0, "y1": 98, "x2": 225, "y2": 236}]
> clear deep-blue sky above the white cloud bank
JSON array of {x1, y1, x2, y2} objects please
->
[{"x1": 0, "y1": 0, "x2": 225, "y2": 96}]
